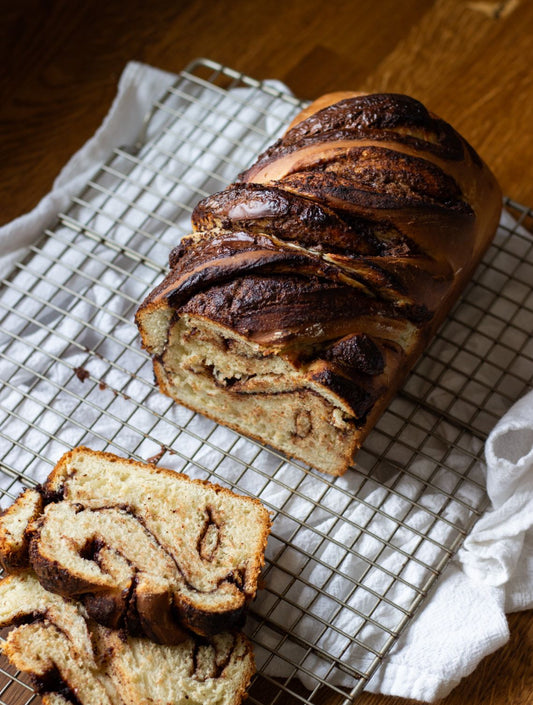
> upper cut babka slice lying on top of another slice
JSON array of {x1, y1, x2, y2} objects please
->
[{"x1": 0, "y1": 448, "x2": 270, "y2": 644}]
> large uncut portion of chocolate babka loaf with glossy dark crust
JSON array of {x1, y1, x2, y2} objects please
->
[{"x1": 136, "y1": 93, "x2": 501, "y2": 475}]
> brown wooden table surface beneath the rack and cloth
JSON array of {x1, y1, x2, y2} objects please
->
[{"x1": 0, "y1": 0, "x2": 533, "y2": 705}]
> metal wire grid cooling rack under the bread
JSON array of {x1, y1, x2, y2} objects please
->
[{"x1": 0, "y1": 60, "x2": 533, "y2": 705}]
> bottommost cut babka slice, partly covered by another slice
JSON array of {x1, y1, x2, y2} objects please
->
[{"x1": 0, "y1": 571, "x2": 255, "y2": 705}]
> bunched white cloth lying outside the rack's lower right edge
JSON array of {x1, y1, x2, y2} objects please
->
[{"x1": 369, "y1": 392, "x2": 533, "y2": 700}]
